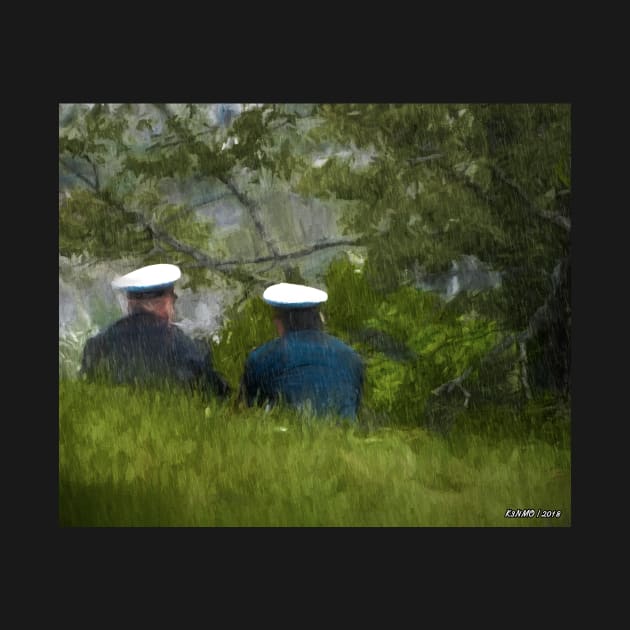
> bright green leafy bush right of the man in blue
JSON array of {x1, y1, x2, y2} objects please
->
[{"x1": 326, "y1": 261, "x2": 520, "y2": 424}]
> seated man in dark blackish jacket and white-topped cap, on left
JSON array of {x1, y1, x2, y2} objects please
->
[{"x1": 81, "y1": 265, "x2": 229, "y2": 398}]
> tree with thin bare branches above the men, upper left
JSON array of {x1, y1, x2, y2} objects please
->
[{"x1": 59, "y1": 104, "x2": 360, "y2": 289}]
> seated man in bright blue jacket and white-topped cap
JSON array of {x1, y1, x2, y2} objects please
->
[{"x1": 241, "y1": 282, "x2": 365, "y2": 420}]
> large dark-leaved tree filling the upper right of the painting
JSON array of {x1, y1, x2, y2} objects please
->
[{"x1": 292, "y1": 104, "x2": 571, "y2": 408}]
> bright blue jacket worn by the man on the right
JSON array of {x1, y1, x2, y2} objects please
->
[{"x1": 242, "y1": 330, "x2": 365, "y2": 419}]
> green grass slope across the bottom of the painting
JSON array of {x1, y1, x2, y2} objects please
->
[{"x1": 59, "y1": 381, "x2": 571, "y2": 527}]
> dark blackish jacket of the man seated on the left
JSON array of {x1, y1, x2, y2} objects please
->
[{"x1": 81, "y1": 313, "x2": 229, "y2": 398}]
